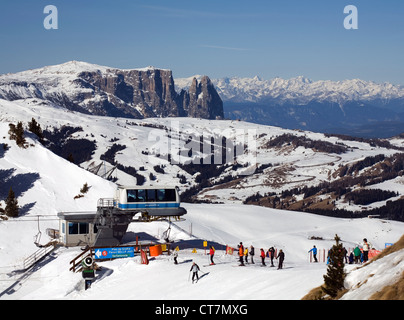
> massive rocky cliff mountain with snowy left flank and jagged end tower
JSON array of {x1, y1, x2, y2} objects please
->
[{"x1": 0, "y1": 61, "x2": 223, "y2": 119}]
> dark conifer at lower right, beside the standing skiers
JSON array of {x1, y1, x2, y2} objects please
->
[{"x1": 321, "y1": 234, "x2": 346, "y2": 298}]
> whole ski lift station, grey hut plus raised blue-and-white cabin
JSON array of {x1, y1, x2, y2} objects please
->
[{"x1": 58, "y1": 186, "x2": 187, "y2": 247}]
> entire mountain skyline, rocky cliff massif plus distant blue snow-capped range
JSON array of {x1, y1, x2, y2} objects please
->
[{"x1": 0, "y1": 61, "x2": 404, "y2": 138}]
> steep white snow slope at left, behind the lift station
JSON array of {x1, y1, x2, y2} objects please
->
[{"x1": 0, "y1": 122, "x2": 116, "y2": 266}]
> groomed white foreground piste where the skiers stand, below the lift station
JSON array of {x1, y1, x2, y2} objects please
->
[{"x1": 0, "y1": 205, "x2": 404, "y2": 300}]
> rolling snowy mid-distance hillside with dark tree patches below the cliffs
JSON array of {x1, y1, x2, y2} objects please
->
[{"x1": 0, "y1": 99, "x2": 404, "y2": 208}]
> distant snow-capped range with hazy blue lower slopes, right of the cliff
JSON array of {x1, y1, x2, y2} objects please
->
[{"x1": 175, "y1": 75, "x2": 404, "y2": 137}]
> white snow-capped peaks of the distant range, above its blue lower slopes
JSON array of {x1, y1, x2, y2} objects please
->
[{"x1": 182, "y1": 76, "x2": 404, "y2": 105}]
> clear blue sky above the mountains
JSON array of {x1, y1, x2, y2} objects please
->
[{"x1": 0, "y1": 0, "x2": 404, "y2": 85}]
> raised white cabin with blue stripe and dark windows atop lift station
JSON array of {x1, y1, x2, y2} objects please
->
[{"x1": 114, "y1": 187, "x2": 187, "y2": 216}]
